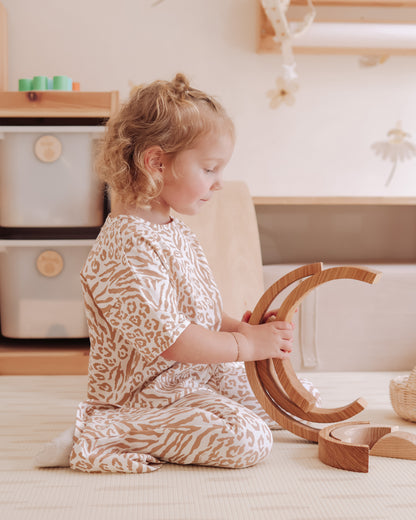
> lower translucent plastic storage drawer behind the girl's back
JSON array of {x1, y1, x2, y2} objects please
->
[{"x1": 0, "y1": 240, "x2": 94, "y2": 339}]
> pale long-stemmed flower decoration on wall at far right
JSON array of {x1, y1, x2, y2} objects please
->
[{"x1": 371, "y1": 121, "x2": 416, "y2": 186}]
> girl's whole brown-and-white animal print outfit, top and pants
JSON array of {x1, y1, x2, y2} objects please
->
[{"x1": 70, "y1": 215, "x2": 314, "y2": 473}]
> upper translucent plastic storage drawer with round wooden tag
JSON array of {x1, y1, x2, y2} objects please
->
[{"x1": 0, "y1": 126, "x2": 104, "y2": 228}]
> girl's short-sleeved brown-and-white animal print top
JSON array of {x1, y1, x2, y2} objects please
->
[{"x1": 81, "y1": 215, "x2": 222, "y2": 407}]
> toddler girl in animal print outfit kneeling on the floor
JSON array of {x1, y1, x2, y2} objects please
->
[{"x1": 37, "y1": 74, "x2": 316, "y2": 473}]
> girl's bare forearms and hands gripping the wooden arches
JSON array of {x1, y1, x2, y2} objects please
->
[{"x1": 162, "y1": 316, "x2": 293, "y2": 363}]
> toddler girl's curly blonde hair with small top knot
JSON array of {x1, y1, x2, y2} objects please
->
[{"x1": 96, "y1": 74, "x2": 234, "y2": 208}]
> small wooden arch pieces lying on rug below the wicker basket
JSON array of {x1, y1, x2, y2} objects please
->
[{"x1": 318, "y1": 422, "x2": 416, "y2": 473}]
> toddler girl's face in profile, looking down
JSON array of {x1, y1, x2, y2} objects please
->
[{"x1": 160, "y1": 131, "x2": 234, "y2": 215}]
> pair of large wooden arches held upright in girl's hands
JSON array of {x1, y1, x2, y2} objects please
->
[{"x1": 246, "y1": 262, "x2": 381, "y2": 442}]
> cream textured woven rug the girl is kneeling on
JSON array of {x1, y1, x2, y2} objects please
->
[{"x1": 0, "y1": 372, "x2": 416, "y2": 520}]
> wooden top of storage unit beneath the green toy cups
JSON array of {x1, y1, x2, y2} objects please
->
[{"x1": 0, "y1": 90, "x2": 118, "y2": 118}]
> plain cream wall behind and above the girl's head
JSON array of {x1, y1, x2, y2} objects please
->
[{"x1": 2, "y1": 0, "x2": 416, "y2": 196}]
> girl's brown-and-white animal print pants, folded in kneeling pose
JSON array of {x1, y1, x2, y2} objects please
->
[{"x1": 70, "y1": 363, "x2": 320, "y2": 473}]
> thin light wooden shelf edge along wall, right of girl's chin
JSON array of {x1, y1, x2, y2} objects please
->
[{"x1": 253, "y1": 197, "x2": 416, "y2": 206}]
